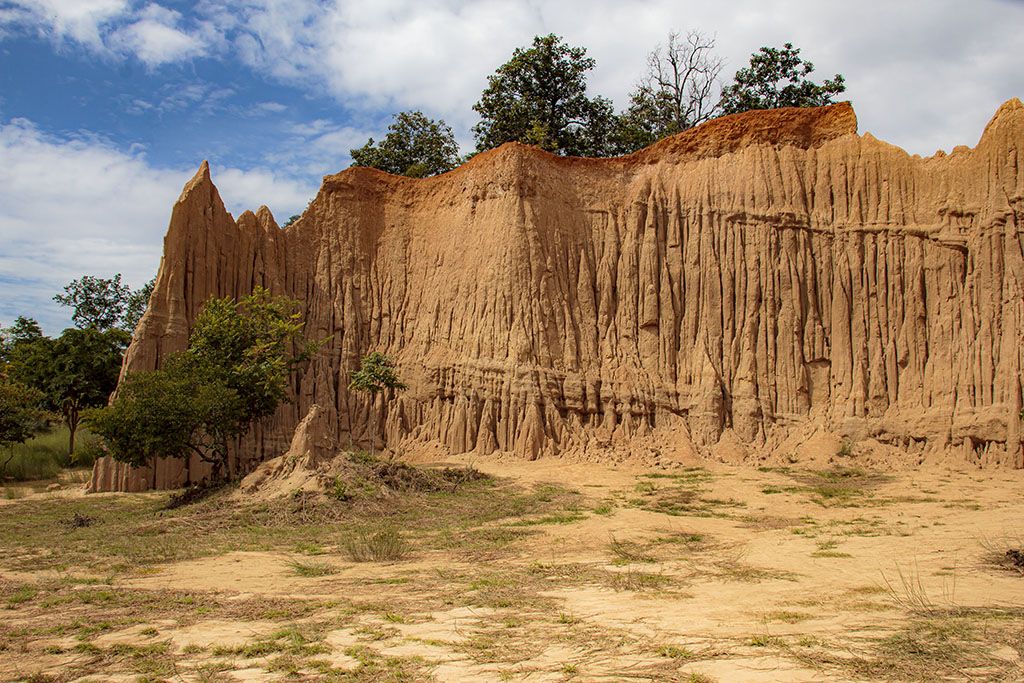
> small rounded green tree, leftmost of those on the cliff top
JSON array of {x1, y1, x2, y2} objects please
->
[{"x1": 350, "y1": 111, "x2": 459, "y2": 178}]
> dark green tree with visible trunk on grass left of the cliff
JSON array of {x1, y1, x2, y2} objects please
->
[{"x1": 7, "y1": 328, "x2": 130, "y2": 454}]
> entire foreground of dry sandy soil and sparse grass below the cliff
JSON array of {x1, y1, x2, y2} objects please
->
[{"x1": 0, "y1": 458, "x2": 1024, "y2": 683}]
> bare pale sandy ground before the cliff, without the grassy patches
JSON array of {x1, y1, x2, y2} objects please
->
[{"x1": 0, "y1": 458, "x2": 1024, "y2": 683}]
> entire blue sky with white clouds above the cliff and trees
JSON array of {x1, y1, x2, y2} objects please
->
[{"x1": 0, "y1": 0, "x2": 1024, "y2": 334}]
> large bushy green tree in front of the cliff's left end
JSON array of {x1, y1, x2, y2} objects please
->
[{"x1": 88, "y1": 288, "x2": 319, "y2": 480}]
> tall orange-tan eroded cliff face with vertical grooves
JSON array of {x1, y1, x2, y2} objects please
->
[{"x1": 93, "y1": 99, "x2": 1024, "y2": 489}]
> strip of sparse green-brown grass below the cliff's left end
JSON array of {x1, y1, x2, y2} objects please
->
[{"x1": 0, "y1": 470, "x2": 584, "y2": 577}]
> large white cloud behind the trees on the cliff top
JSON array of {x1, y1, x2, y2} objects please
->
[{"x1": 201, "y1": 0, "x2": 1024, "y2": 154}]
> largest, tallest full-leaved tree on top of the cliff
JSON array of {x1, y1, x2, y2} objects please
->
[{"x1": 473, "y1": 34, "x2": 614, "y2": 157}]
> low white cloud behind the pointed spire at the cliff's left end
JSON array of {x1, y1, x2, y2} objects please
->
[{"x1": 0, "y1": 119, "x2": 315, "y2": 333}]
